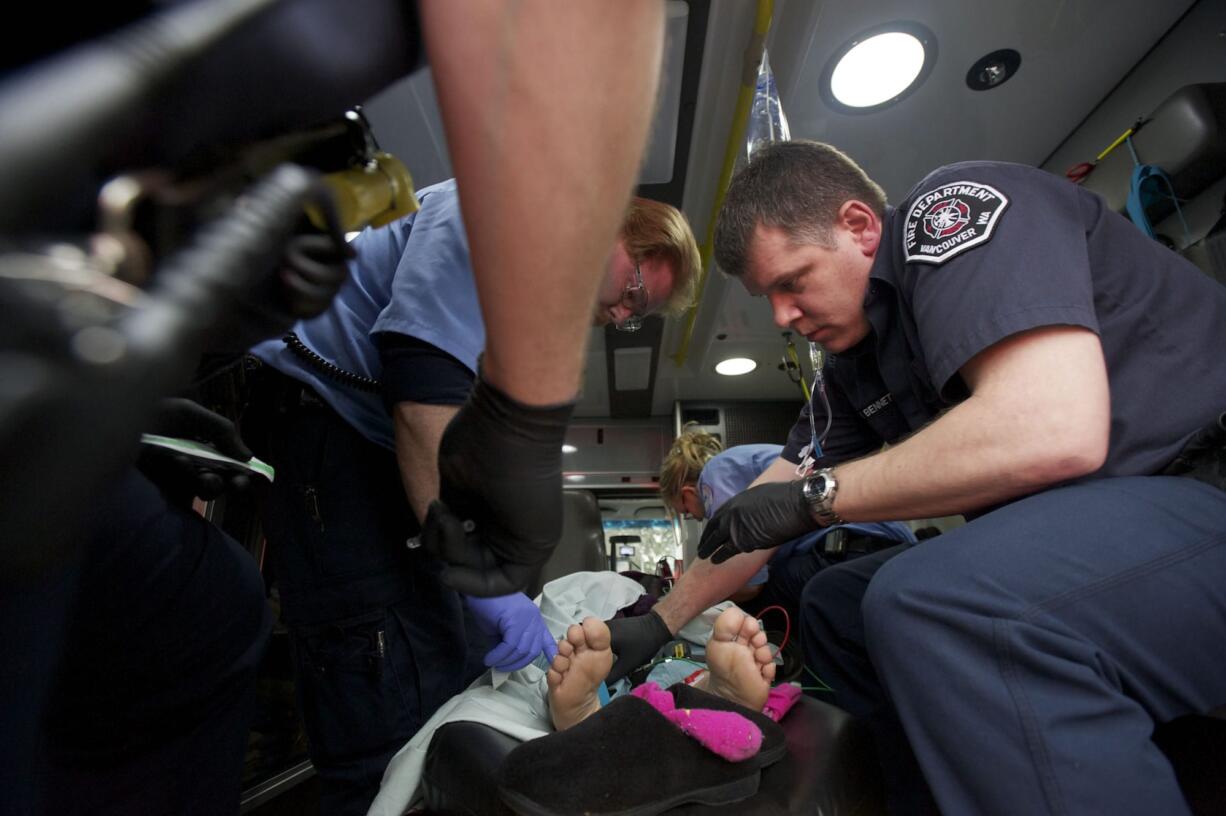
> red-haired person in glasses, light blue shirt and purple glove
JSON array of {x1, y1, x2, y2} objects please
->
[{"x1": 243, "y1": 180, "x2": 700, "y2": 814}]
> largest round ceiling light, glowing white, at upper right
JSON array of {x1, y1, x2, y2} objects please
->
[{"x1": 820, "y1": 22, "x2": 937, "y2": 113}]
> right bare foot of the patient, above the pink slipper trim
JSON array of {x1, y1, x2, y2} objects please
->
[{"x1": 696, "y1": 606, "x2": 775, "y2": 711}]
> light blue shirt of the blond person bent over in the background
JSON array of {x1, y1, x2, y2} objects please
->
[{"x1": 698, "y1": 445, "x2": 916, "y2": 586}]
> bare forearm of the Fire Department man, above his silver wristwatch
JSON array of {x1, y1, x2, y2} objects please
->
[{"x1": 834, "y1": 326, "x2": 1111, "y2": 521}]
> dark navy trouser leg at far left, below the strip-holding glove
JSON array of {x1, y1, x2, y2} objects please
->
[{"x1": 31, "y1": 470, "x2": 272, "y2": 816}]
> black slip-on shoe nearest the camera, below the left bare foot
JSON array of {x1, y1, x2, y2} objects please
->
[{"x1": 498, "y1": 696, "x2": 761, "y2": 816}]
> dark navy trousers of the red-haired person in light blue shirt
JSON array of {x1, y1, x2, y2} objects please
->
[{"x1": 243, "y1": 382, "x2": 466, "y2": 816}]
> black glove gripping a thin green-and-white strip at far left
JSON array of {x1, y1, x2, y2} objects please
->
[{"x1": 137, "y1": 397, "x2": 251, "y2": 505}]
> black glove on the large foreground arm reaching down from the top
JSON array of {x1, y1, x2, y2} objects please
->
[{"x1": 422, "y1": 374, "x2": 575, "y2": 598}]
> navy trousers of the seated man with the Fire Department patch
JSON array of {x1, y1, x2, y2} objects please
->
[{"x1": 802, "y1": 477, "x2": 1226, "y2": 816}]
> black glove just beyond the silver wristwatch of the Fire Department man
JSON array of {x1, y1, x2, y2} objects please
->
[{"x1": 698, "y1": 482, "x2": 818, "y2": 564}]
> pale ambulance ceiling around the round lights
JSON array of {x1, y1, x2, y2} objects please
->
[{"x1": 367, "y1": 0, "x2": 1226, "y2": 419}]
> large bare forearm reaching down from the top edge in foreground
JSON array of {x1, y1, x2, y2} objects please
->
[{"x1": 421, "y1": 0, "x2": 664, "y2": 406}]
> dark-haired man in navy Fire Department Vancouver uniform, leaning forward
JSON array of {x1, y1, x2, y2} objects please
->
[{"x1": 699, "y1": 142, "x2": 1226, "y2": 816}]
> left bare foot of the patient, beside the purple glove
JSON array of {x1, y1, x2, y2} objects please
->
[{"x1": 546, "y1": 618, "x2": 613, "y2": 731}]
